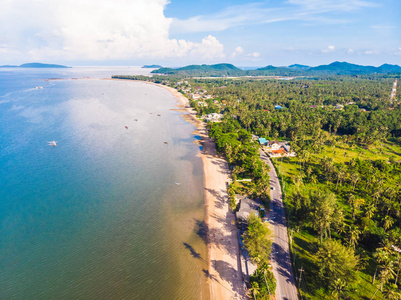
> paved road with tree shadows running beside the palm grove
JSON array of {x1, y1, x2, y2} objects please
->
[{"x1": 260, "y1": 150, "x2": 298, "y2": 300}]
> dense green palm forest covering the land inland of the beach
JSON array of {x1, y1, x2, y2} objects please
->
[{"x1": 114, "y1": 74, "x2": 401, "y2": 299}]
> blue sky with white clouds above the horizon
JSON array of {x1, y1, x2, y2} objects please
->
[{"x1": 0, "y1": 0, "x2": 401, "y2": 67}]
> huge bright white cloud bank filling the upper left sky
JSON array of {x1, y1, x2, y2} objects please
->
[{"x1": 0, "y1": 0, "x2": 224, "y2": 61}]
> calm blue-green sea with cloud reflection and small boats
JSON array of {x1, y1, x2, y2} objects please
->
[{"x1": 0, "y1": 67, "x2": 209, "y2": 299}]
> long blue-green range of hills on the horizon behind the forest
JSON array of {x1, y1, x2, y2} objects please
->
[{"x1": 152, "y1": 61, "x2": 401, "y2": 77}]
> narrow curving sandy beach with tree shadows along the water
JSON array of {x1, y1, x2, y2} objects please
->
[{"x1": 157, "y1": 84, "x2": 247, "y2": 300}]
